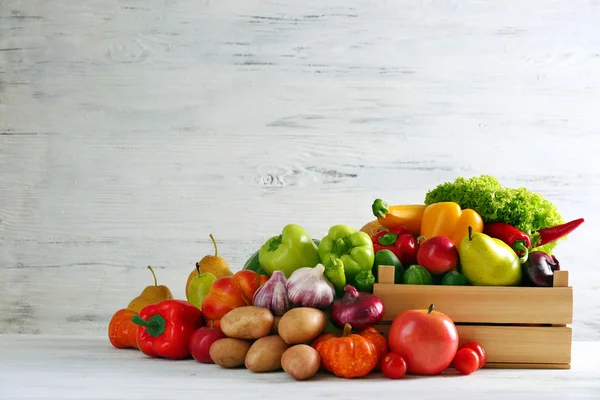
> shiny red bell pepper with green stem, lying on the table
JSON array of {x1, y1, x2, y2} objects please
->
[{"x1": 131, "y1": 299, "x2": 205, "y2": 360}]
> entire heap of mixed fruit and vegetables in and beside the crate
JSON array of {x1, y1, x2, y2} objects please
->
[{"x1": 108, "y1": 177, "x2": 583, "y2": 380}]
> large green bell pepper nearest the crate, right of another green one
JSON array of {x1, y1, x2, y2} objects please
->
[{"x1": 318, "y1": 225, "x2": 375, "y2": 289}]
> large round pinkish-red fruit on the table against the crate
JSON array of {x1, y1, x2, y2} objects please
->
[{"x1": 388, "y1": 304, "x2": 458, "y2": 375}]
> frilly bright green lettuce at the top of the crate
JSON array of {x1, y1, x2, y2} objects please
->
[{"x1": 425, "y1": 175, "x2": 565, "y2": 254}]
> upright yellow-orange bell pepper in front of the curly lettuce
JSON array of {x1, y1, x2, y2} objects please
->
[{"x1": 421, "y1": 201, "x2": 484, "y2": 248}]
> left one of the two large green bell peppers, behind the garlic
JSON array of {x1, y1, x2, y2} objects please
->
[{"x1": 258, "y1": 224, "x2": 320, "y2": 278}]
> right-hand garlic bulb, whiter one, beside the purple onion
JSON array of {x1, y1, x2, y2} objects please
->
[{"x1": 285, "y1": 264, "x2": 335, "y2": 309}]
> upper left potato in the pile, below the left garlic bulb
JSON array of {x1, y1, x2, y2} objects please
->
[{"x1": 221, "y1": 306, "x2": 274, "y2": 339}]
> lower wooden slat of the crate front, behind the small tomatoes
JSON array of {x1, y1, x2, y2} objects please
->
[{"x1": 375, "y1": 323, "x2": 572, "y2": 368}]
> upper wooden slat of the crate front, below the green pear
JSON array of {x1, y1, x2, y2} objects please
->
[{"x1": 373, "y1": 283, "x2": 573, "y2": 325}]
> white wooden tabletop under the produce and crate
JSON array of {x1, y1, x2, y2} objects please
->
[{"x1": 0, "y1": 335, "x2": 600, "y2": 400}]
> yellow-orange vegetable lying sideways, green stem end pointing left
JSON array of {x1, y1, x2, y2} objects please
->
[{"x1": 371, "y1": 199, "x2": 427, "y2": 237}]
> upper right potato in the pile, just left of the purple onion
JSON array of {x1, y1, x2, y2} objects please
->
[{"x1": 278, "y1": 307, "x2": 327, "y2": 344}]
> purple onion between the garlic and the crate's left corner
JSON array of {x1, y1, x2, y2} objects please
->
[{"x1": 330, "y1": 285, "x2": 384, "y2": 330}]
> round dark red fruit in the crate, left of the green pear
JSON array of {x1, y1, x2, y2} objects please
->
[{"x1": 417, "y1": 236, "x2": 458, "y2": 275}]
